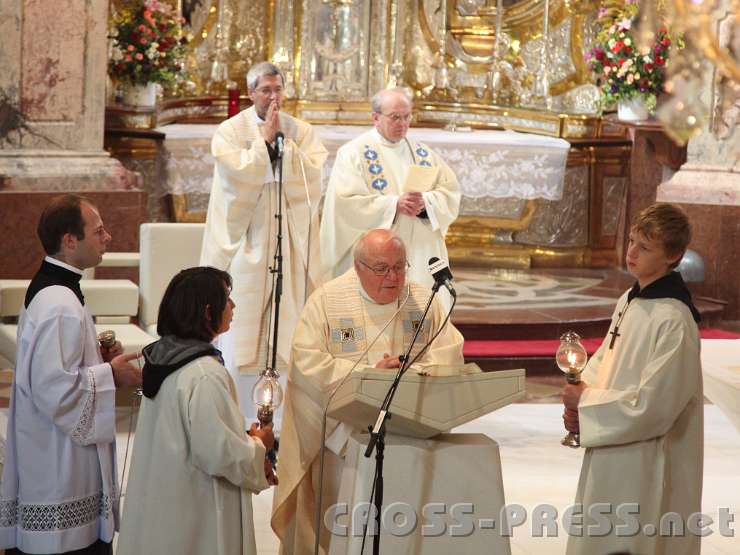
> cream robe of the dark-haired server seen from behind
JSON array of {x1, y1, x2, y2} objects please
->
[{"x1": 116, "y1": 356, "x2": 268, "y2": 555}]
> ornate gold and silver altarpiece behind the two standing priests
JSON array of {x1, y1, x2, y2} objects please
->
[{"x1": 142, "y1": 0, "x2": 598, "y2": 137}]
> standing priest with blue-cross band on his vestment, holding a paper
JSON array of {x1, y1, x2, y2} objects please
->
[{"x1": 321, "y1": 89, "x2": 460, "y2": 306}]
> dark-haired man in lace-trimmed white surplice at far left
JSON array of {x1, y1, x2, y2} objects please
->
[{"x1": 0, "y1": 195, "x2": 141, "y2": 555}]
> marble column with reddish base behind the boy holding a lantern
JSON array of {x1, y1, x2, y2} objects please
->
[{"x1": 657, "y1": 0, "x2": 740, "y2": 320}]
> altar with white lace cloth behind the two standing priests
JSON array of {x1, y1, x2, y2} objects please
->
[{"x1": 140, "y1": 124, "x2": 588, "y2": 266}]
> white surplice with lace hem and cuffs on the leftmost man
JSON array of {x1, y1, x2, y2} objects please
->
[{"x1": 0, "y1": 278, "x2": 118, "y2": 553}]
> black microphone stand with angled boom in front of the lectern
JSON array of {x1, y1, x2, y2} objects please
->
[{"x1": 363, "y1": 283, "x2": 441, "y2": 555}]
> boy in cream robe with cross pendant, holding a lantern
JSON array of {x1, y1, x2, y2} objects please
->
[{"x1": 563, "y1": 204, "x2": 704, "y2": 555}]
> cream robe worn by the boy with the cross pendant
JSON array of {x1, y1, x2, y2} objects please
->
[{"x1": 568, "y1": 294, "x2": 704, "y2": 555}]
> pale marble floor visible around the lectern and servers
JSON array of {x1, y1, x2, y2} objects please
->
[{"x1": 110, "y1": 402, "x2": 740, "y2": 555}]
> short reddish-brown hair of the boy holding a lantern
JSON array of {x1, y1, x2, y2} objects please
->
[{"x1": 630, "y1": 202, "x2": 691, "y2": 268}]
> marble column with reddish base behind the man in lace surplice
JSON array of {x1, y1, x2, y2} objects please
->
[{"x1": 0, "y1": 0, "x2": 144, "y2": 278}]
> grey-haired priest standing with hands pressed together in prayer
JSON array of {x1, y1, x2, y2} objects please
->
[{"x1": 200, "y1": 62, "x2": 327, "y2": 414}]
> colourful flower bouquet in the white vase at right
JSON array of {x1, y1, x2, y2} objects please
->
[{"x1": 585, "y1": 0, "x2": 671, "y2": 112}]
